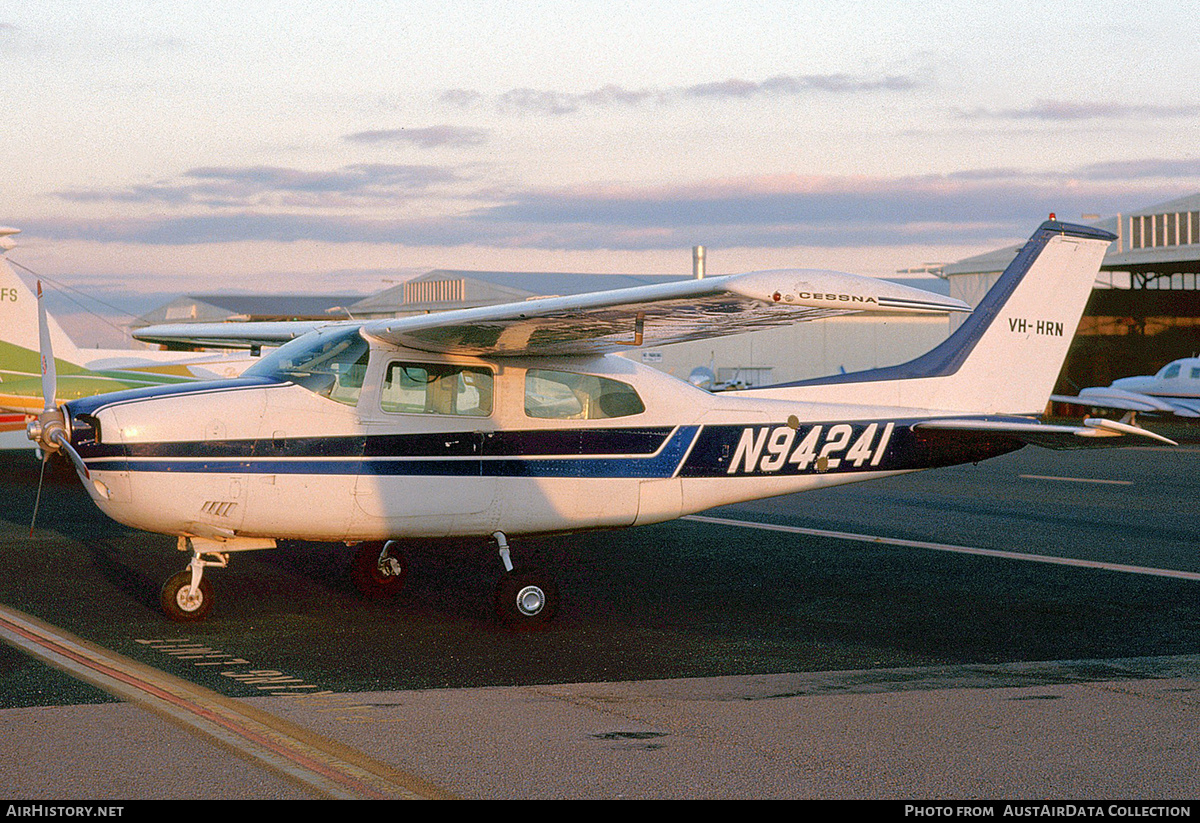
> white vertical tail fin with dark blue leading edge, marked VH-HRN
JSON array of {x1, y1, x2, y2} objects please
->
[{"x1": 755, "y1": 220, "x2": 1116, "y2": 414}]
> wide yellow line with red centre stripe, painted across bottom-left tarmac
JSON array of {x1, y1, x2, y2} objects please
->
[{"x1": 0, "y1": 606, "x2": 452, "y2": 800}]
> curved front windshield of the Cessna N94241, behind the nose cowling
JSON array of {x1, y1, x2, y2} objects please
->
[{"x1": 245, "y1": 328, "x2": 371, "y2": 406}]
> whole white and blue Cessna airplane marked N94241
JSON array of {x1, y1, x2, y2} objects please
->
[{"x1": 29, "y1": 220, "x2": 1170, "y2": 626}]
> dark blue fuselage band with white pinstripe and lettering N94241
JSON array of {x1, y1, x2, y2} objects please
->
[{"x1": 79, "y1": 419, "x2": 1024, "y2": 480}]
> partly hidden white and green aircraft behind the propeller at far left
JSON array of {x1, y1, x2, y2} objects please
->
[{"x1": 0, "y1": 228, "x2": 257, "y2": 449}]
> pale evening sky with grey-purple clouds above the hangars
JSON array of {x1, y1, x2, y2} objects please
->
[{"x1": 0, "y1": 0, "x2": 1200, "y2": 343}]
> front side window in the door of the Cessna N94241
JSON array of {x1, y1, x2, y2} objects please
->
[{"x1": 379, "y1": 362, "x2": 492, "y2": 417}]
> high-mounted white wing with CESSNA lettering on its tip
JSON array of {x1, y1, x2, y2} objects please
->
[{"x1": 133, "y1": 269, "x2": 971, "y2": 355}]
